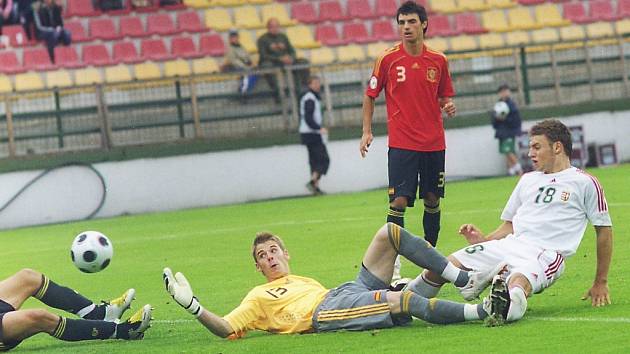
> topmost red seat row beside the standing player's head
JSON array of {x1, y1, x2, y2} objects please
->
[{"x1": 291, "y1": 0, "x2": 427, "y2": 23}]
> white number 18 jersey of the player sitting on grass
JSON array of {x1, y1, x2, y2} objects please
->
[{"x1": 501, "y1": 167, "x2": 612, "y2": 257}]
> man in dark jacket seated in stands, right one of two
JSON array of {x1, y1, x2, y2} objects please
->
[{"x1": 257, "y1": 17, "x2": 309, "y2": 100}]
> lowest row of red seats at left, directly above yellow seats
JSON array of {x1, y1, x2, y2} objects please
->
[{"x1": 0, "y1": 33, "x2": 225, "y2": 74}]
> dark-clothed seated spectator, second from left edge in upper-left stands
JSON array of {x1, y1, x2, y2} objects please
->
[{"x1": 35, "y1": 0, "x2": 72, "y2": 63}]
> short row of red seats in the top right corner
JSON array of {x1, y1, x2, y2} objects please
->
[{"x1": 562, "y1": 0, "x2": 630, "y2": 23}]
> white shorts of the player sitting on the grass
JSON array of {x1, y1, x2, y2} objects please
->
[{"x1": 453, "y1": 235, "x2": 564, "y2": 293}]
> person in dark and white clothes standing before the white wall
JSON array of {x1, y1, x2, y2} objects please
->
[{"x1": 299, "y1": 76, "x2": 330, "y2": 195}]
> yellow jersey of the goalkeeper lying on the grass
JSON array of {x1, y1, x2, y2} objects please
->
[{"x1": 223, "y1": 275, "x2": 328, "y2": 337}]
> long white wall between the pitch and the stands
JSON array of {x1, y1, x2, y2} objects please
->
[{"x1": 0, "y1": 111, "x2": 630, "y2": 229}]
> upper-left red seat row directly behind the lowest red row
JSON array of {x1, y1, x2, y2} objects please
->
[{"x1": 3, "y1": 11, "x2": 208, "y2": 47}]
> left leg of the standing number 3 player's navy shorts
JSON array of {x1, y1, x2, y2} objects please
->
[{"x1": 387, "y1": 148, "x2": 419, "y2": 207}]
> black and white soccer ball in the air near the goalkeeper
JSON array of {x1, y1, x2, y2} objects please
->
[{"x1": 70, "y1": 231, "x2": 114, "y2": 273}]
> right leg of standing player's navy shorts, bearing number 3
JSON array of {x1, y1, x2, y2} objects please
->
[{"x1": 418, "y1": 150, "x2": 446, "y2": 198}]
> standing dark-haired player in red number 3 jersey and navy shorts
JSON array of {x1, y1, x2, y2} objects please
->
[{"x1": 359, "y1": 1, "x2": 457, "y2": 278}]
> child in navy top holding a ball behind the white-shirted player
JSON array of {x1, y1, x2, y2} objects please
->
[{"x1": 492, "y1": 84, "x2": 523, "y2": 176}]
